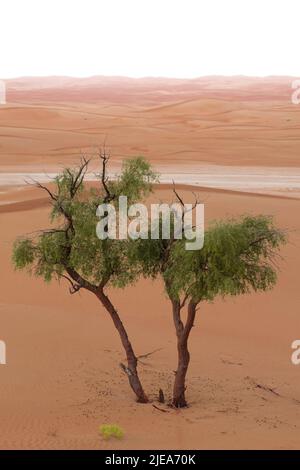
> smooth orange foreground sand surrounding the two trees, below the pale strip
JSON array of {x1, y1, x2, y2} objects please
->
[{"x1": 0, "y1": 184, "x2": 300, "y2": 449}]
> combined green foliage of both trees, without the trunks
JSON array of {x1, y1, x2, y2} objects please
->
[{"x1": 12, "y1": 157, "x2": 285, "y2": 310}]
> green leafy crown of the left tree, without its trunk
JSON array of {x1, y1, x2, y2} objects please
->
[{"x1": 12, "y1": 157, "x2": 157, "y2": 287}]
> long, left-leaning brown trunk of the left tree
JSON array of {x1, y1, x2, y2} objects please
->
[{"x1": 96, "y1": 290, "x2": 149, "y2": 403}]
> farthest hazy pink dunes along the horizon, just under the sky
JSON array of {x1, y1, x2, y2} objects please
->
[{"x1": 6, "y1": 76, "x2": 293, "y2": 103}]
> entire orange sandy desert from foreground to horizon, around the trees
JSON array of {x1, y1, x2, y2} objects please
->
[{"x1": 0, "y1": 77, "x2": 300, "y2": 449}]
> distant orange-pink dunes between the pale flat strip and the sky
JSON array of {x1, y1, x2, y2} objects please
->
[{"x1": 0, "y1": 77, "x2": 300, "y2": 171}]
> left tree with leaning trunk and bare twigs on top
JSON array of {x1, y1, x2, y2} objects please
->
[{"x1": 12, "y1": 150, "x2": 156, "y2": 403}]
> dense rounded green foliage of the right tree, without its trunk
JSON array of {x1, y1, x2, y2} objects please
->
[{"x1": 164, "y1": 216, "x2": 285, "y2": 302}]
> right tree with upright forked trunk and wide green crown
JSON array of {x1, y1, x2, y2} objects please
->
[{"x1": 131, "y1": 207, "x2": 285, "y2": 408}]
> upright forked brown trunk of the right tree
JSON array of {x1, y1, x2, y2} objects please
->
[{"x1": 172, "y1": 301, "x2": 196, "y2": 408}]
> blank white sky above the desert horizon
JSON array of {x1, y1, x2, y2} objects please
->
[{"x1": 0, "y1": 0, "x2": 300, "y2": 78}]
